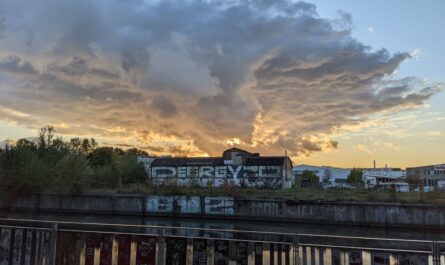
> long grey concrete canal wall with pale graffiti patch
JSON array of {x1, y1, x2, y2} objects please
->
[{"x1": 3, "y1": 194, "x2": 445, "y2": 229}]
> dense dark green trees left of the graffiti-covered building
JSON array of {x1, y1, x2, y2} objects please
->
[{"x1": 0, "y1": 126, "x2": 148, "y2": 199}]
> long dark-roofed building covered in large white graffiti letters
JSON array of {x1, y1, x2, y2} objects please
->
[{"x1": 149, "y1": 148, "x2": 293, "y2": 189}]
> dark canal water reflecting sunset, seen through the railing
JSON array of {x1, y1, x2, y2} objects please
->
[{"x1": 0, "y1": 212, "x2": 445, "y2": 265}]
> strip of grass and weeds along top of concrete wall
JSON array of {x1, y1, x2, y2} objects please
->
[{"x1": 83, "y1": 184, "x2": 445, "y2": 204}]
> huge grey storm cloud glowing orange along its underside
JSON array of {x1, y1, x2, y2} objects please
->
[{"x1": 0, "y1": 0, "x2": 440, "y2": 155}]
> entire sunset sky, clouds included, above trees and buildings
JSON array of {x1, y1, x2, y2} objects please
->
[{"x1": 0, "y1": 0, "x2": 445, "y2": 168}]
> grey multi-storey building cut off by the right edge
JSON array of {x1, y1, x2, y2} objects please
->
[{"x1": 406, "y1": 164, "x2": 445, "y2": 188}]
